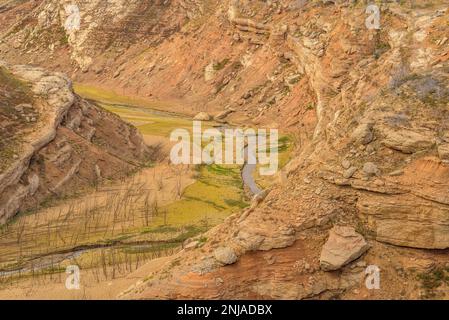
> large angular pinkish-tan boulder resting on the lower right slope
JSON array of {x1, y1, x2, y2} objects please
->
[{"x1": 320, "y1": 226, "x2": 369, "y2": 271}]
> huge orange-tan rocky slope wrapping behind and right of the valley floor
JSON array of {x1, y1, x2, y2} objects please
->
[{"x1": 0, "y1": 0, "x2": 449, "y2": 299}]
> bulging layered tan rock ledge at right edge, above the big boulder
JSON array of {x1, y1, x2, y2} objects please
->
[{"x1": 357, "y1": 157, "x2": 449, "y2": 249}]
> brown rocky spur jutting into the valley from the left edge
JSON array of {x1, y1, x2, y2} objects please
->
[{"x1": 0, "y1": 64, "x2": 151, "y2": 223}]
